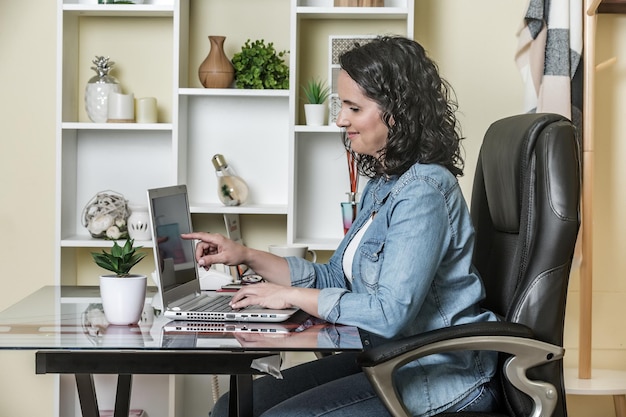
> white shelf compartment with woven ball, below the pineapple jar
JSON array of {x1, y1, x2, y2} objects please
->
[{"x1": 60, "y1": 130, "x2": 176, "y2": 240}]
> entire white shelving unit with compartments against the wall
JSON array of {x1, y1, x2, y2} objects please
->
[{"x1": 55, "y1": 0, "x2": 414, "y2": 417}]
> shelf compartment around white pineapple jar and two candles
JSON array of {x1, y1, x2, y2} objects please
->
[{"x1": 58, "y1": 14, "x2": 177, "y2": 124}]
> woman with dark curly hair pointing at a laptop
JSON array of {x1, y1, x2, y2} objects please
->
[{"x1": 184, "y1": 37, "x2": 497, "y2": 417}]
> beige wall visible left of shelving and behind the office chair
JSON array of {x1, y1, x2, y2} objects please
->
[{"x1": 0, "y1": 0, "x2": 626, "y2": 417}]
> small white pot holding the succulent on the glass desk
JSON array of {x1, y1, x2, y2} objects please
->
[{"x1": 100, "y1": 275, "x2": 146, "y2": 325}]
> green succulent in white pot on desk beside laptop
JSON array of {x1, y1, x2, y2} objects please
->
[{"x1": 91, "y1": 239, "x2": 146, "y2": 325}]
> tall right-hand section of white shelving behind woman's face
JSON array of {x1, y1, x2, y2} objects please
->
[{"x1": 287, "y1": 0, "x2": 414, "y2": 250}]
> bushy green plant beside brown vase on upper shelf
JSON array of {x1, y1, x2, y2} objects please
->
[{"x1": 232, "y1": 39, "x2": 289, "y2": 90}]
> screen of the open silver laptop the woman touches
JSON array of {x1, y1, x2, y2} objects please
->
[{"x1": 148, "y1": 185, "x2": 196, "y2": 293}]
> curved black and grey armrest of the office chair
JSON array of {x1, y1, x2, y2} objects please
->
[{"x1": 358, "y1": 322, "x2": 565, "y2": 417}]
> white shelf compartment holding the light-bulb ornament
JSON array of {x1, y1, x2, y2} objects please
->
[{"x1": 180, "y1": 94, "x2": 289, "y2": 208}]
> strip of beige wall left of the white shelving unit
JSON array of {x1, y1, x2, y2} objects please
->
[{"x1": 0, "y1": 0, "x2": 56, "y2": 416}]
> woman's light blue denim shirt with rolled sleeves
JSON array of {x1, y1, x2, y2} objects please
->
[{"x1": 287, "y1": 163, "x2": 497, "y2": 416}]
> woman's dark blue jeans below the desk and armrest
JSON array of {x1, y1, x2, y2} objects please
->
[{"x1": 210, "y1": 353, "x2": 497, "y2": 417}]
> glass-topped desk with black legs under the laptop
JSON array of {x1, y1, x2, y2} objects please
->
[{"x1": 0, "y1": 286, "x2": 362, "y2": 417}]
